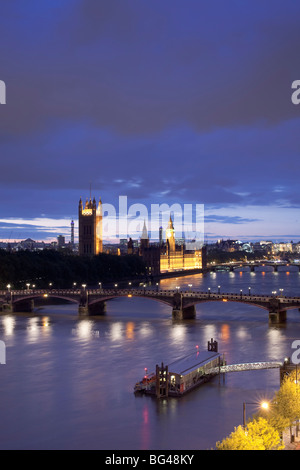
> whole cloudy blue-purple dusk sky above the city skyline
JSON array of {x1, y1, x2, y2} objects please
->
[{"x1": 0, "y1": 0, "x2": 300, "y2": 241}]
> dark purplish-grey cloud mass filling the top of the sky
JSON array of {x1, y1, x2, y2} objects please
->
[{"x1": 0, "y1": 0, "x2": 300, "y2": 134}]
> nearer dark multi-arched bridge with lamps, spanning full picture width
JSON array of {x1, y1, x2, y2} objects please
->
[{"x1": 0, "y1": 287, "x2": 300, "y2": 323}]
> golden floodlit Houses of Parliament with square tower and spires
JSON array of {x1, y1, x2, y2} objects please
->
[{"x1": 78, "y1": 197, "x2": 206, "y2": 276}]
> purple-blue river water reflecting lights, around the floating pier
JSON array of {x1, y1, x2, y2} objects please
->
[{"x1": 0, "y1": 268, "x2": 300, "y2": 450}]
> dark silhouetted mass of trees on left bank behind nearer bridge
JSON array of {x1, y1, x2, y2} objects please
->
[{"x1": 0, "y1": 250, "x2": 146, "y2": 289}]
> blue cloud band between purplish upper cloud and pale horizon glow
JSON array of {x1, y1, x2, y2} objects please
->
[{"x1": 0, "y1": 121, "x2": 300, "y2": 215}]
